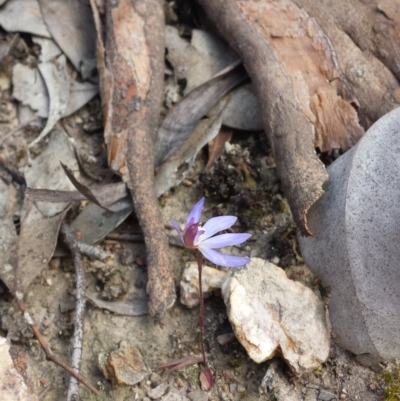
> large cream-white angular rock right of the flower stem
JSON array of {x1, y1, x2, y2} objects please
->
[{"x1": 222, "y1": 258, "x2": 330, "y2": 374}]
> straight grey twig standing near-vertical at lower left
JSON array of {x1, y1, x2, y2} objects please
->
[{"x1": 67, "y1": 243, "x2": 86, "y2": 401}]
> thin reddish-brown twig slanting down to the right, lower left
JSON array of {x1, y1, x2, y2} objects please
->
[{"x1": 15, "y1": 292, "x2": 99, "y2": 395}]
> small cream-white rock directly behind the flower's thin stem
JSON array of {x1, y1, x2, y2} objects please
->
[{"x1": 180, "y1": 263, "x2": 228, "y2": 308}]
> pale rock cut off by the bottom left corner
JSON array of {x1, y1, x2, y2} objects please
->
[{"x1": 0, "y1": 337, "x2": 38, "y2": 401}]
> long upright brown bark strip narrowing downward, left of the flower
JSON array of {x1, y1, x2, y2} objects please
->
[{"x1": 91, "y1": 0, "x2": 176, "y2": 321}]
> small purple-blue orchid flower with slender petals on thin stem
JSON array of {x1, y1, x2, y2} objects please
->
[{"x1": 171, "y1": 198, "x2": 251, "y2": 267}]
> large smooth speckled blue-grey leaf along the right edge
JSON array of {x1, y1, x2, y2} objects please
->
[{"x1": 299, "y1": 108, "x2": 400, "y2": 364}]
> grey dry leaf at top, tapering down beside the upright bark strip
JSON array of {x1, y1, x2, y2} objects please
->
[{"x1": 39, "y1": 0, "x2": 96, "y2": 79}]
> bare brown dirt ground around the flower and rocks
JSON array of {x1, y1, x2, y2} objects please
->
[{"x1": 0, "y1": 116, "x2": 390, "y2": 401}]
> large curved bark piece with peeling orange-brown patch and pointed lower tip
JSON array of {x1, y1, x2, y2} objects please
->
[{"x1": 198, "y1": 0, "x2": 363, "y2": 234}]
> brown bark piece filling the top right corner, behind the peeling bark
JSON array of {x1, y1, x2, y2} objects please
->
[{"x1": 293, "y1": 0, "x2": 400, "y2": 126}]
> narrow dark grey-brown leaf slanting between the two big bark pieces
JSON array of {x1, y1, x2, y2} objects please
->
[{"x1": 154, "y1": 64, "x2": 247, "y2": 167}]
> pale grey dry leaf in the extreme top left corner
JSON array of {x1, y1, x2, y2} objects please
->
[{"x1": 0, "y1": 0, "x2": 51, "y2": 38}]
